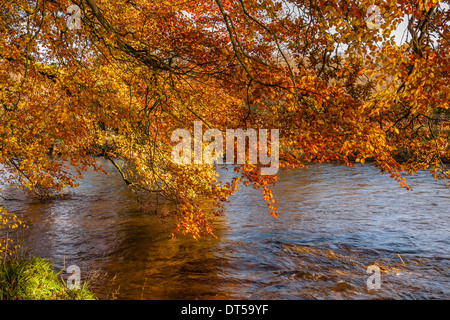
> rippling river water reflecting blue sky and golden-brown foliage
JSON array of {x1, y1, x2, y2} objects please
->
[{"x1": 0, "y1": 162, "x2": 450, "y2": 299}]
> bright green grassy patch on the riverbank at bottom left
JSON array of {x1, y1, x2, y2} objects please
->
[{"x1": 0, "y1": 256, "x2": 97, "y2": 300}]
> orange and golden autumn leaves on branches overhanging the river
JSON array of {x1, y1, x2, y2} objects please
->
[{"x1": 0, "y1": 0, "x2": 450, "y2": 237}]
